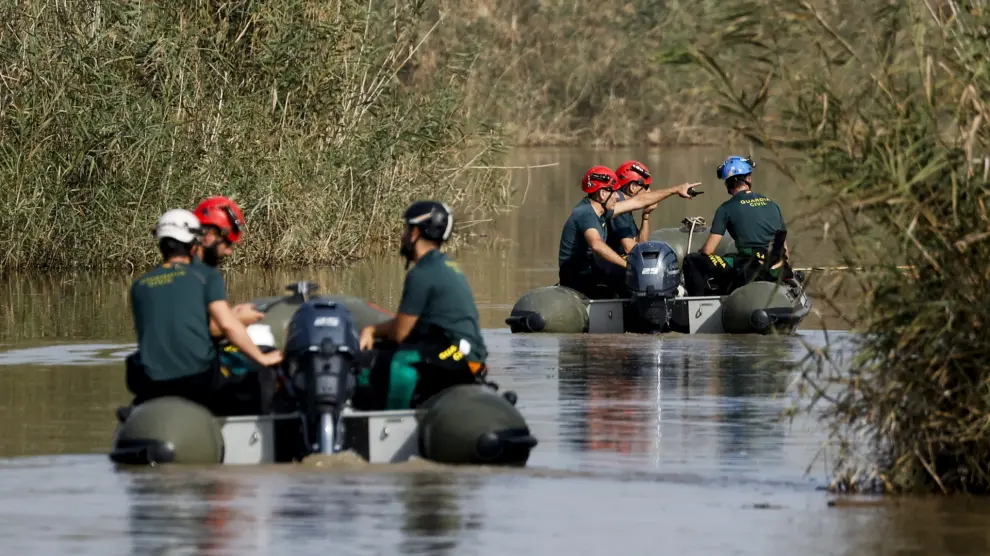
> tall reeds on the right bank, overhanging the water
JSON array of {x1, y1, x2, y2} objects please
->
[{"x1": 668, "y1": 0, "x2": 990, "y2": 493}]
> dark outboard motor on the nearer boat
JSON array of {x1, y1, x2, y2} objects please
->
[{"x1": 284, "y1": 298, "x2": 360, "y2": 454}]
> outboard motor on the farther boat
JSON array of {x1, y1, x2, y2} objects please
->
[{"x1": 626, "y1": 241, "x2": 681, "y2": 332}]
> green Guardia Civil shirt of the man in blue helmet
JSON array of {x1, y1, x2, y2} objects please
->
[{"x1": 711, "y1": 191, "x2": 787, "y2": 250}]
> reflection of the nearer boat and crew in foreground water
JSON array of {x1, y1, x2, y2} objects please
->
[{"x1": 127, "y1": 464, "x2": 485, "y2": 555}]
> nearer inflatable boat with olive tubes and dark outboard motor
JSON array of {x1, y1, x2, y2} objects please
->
[{"x1": 109, "y1": 282, "x2": 537, "y2": 466}]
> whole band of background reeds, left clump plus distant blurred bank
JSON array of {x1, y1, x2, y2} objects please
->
[{"x1": 0, "y1": 0, "x2": 948, "y2": 273}]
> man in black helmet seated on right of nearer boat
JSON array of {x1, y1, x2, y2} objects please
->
[{"x1": 355, "y1": 201, "x2": 488, "y2": 409}]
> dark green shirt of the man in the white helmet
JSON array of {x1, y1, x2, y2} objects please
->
[{"x1": 131, "y1": 261, "x2": 225, "y2": 381}]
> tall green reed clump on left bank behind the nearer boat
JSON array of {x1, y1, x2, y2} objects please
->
[{"x1": 0, "y1": 0, "x2": 508, "y2": 272}]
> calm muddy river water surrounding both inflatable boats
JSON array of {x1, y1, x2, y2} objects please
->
[{"x1": 0, "y1": 149, "x2": 990, "y2": 556}]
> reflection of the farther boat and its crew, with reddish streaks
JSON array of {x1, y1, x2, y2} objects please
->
[{"x1": 558, "y1": 335, "x2": 797, "y2": 475}]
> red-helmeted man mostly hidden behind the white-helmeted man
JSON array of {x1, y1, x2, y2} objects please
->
[{"x1": 193, "y1": 196, "x2": 265, "y2": 337}]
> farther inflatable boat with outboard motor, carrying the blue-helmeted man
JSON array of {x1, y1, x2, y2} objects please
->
[{"x1": 505, "y1": 217, "x2": 811, "y2": 334}]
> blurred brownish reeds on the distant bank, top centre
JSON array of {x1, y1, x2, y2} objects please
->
[{"x1": 416, "y1": 0, "x2": 726, "y2": 147}]
